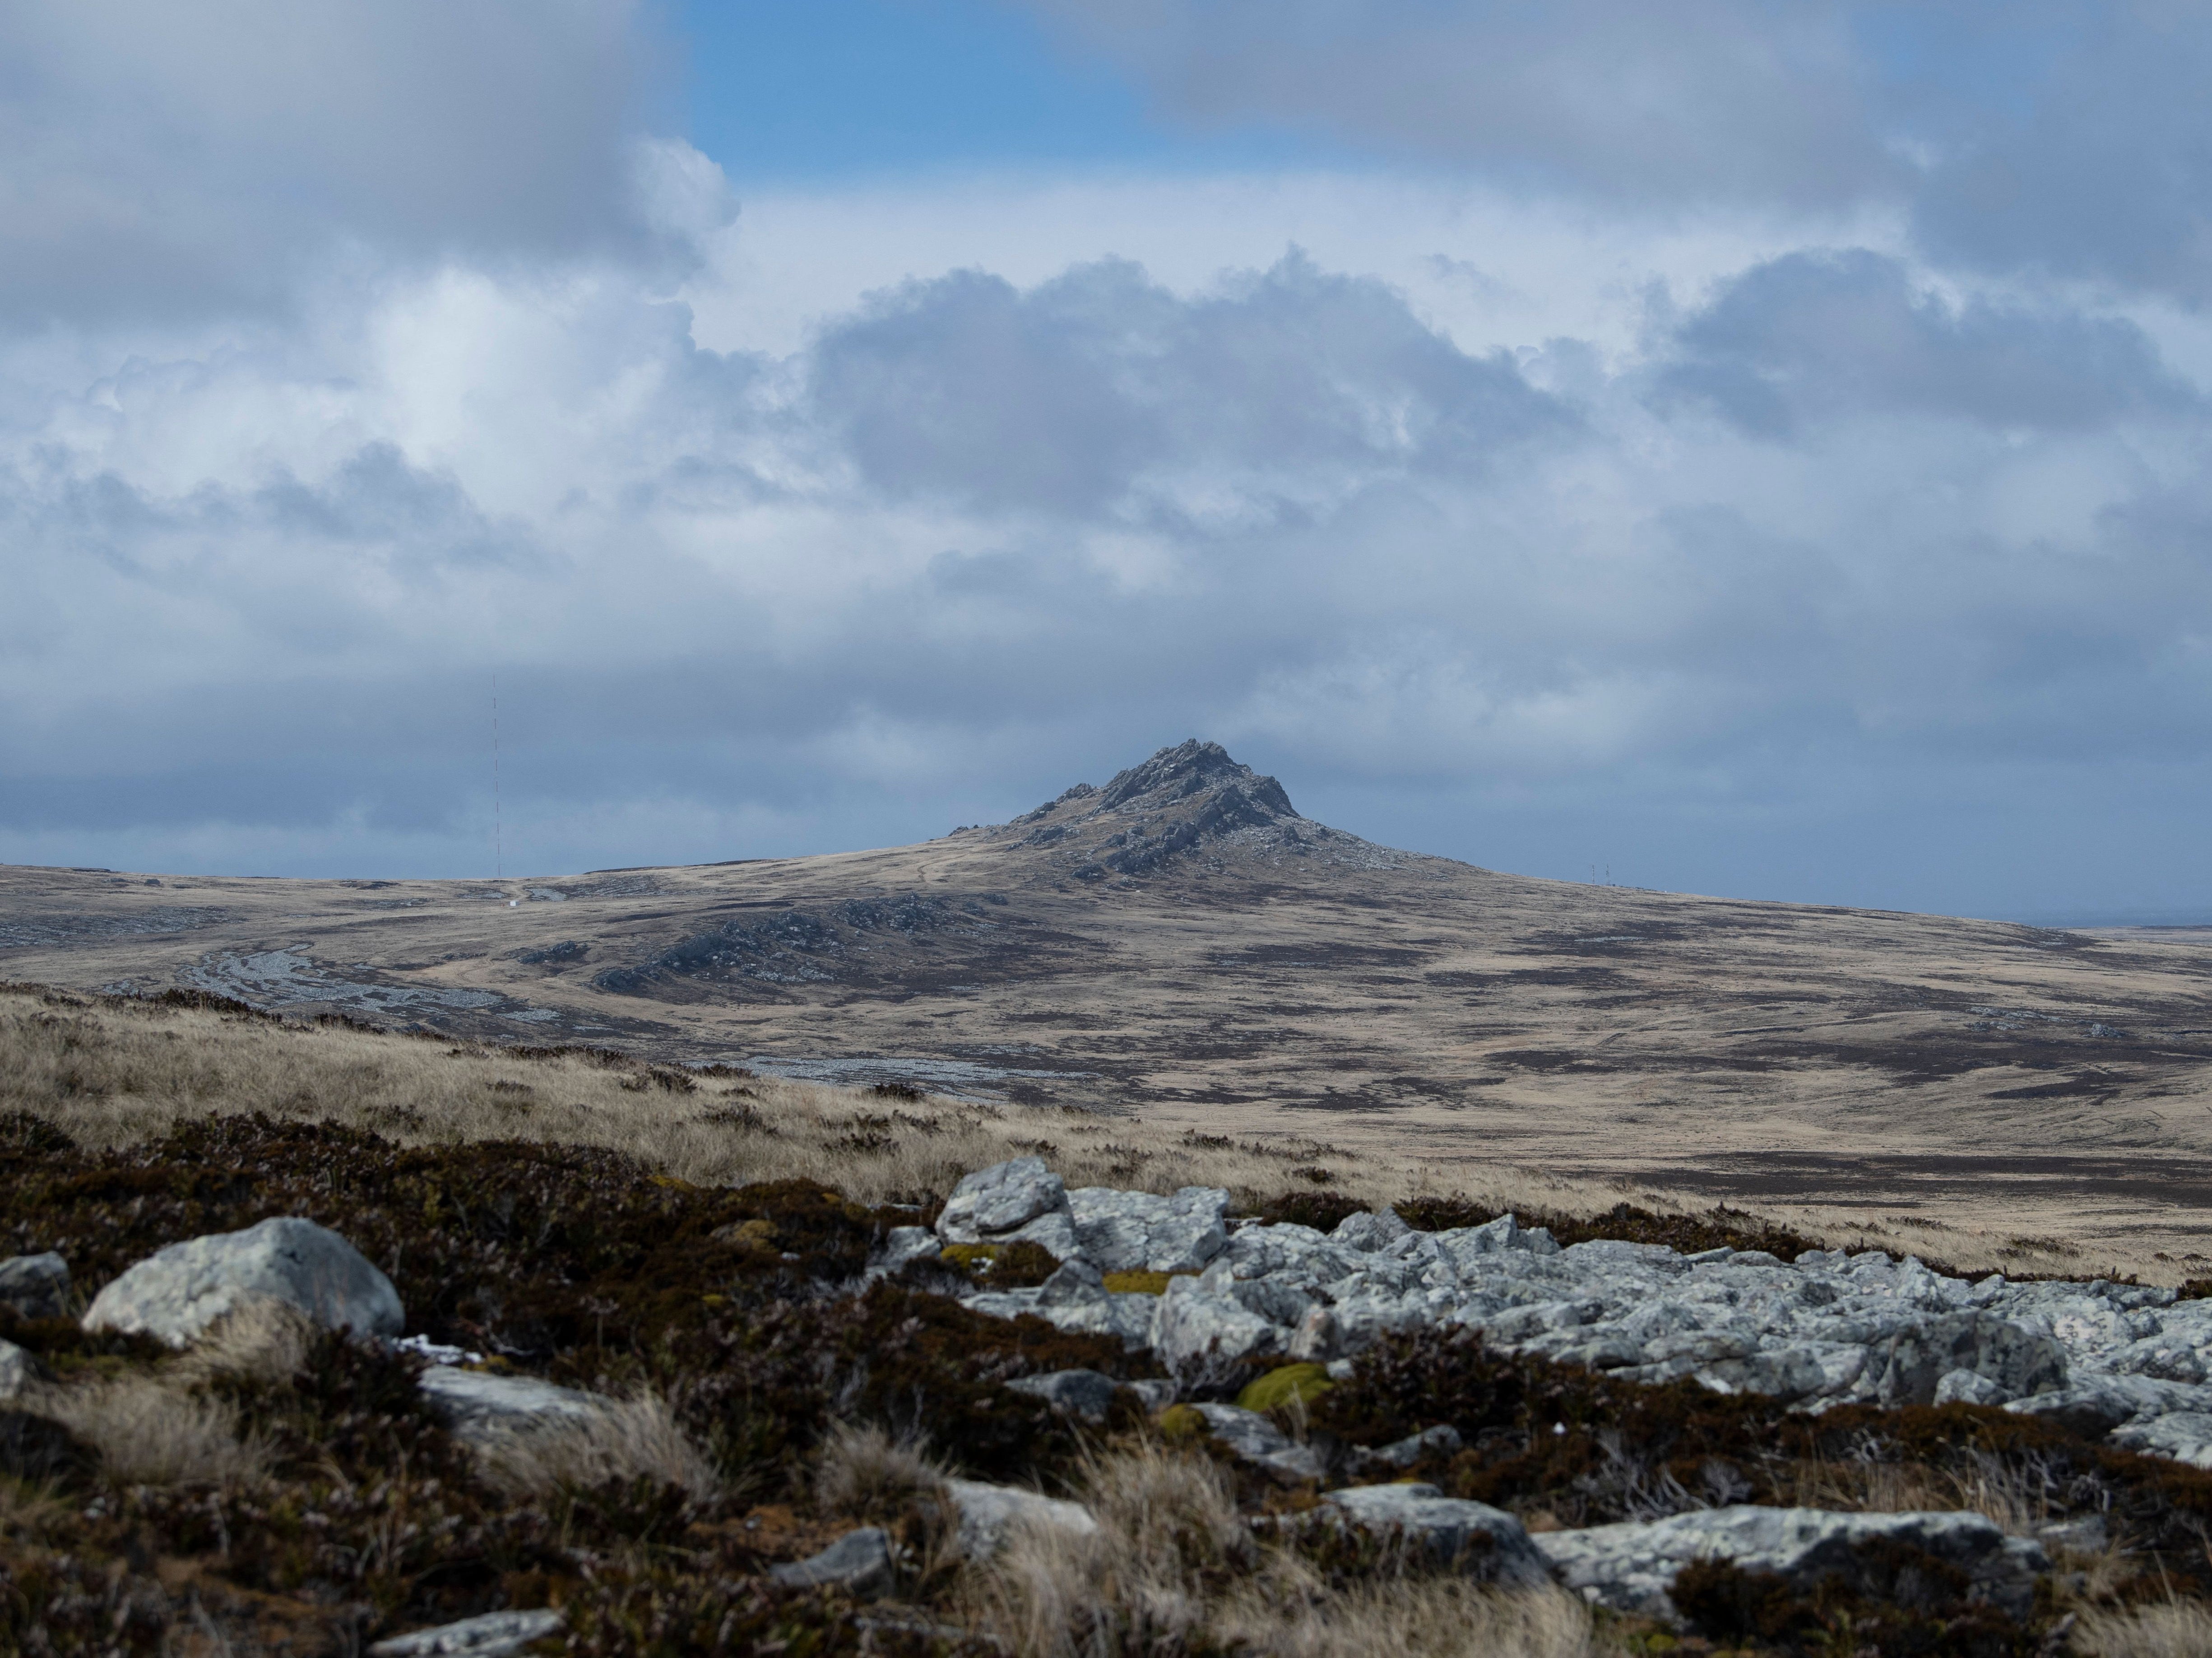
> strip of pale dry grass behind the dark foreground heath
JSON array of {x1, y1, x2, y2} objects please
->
[{"x1": 0, "y1": 985, "x2": 2022, "y2": 1271}]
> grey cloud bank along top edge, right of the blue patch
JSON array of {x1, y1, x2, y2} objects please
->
[{"x1": 1026, "y1": 0, "x2": 2212, "y2": 306}]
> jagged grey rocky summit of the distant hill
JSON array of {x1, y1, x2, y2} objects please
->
[{"x1": 1006, "y1": 737, "x2": 1330, "y2": 881}]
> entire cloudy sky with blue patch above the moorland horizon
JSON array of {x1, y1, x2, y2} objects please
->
[{"x1": 0, "y1": 0, "x2": 2212, "y2": 923}]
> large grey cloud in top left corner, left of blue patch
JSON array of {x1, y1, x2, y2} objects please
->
[{"x1": 0, "y1": 0, "x2": 690, "y2": 325}]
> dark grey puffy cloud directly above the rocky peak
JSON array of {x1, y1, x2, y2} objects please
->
[{"x1": 812, "y1": 250, "x2": 1573, "y2": 511}]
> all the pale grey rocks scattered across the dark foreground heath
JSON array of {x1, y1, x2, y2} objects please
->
[{"x1": 13, "y1": 1158, "x2": 2212, "y2": 1653}]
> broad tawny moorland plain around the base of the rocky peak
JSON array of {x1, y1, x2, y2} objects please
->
[{"x1": 0, "y1": 801, "x2": 2212, "y2": 1282}]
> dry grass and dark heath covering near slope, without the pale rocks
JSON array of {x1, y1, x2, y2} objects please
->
[{"x1": 0, "y1": 987, "x2": 2212, "y2": 1658}]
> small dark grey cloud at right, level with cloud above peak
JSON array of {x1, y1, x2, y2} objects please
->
[{"x1": 1657, "y1": 248, "x2": 2199, "y2": 438}]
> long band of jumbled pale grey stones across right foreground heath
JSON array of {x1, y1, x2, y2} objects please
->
[{"x1": 938, "y1": 1158, "x2": 2212, "y2": 1468}]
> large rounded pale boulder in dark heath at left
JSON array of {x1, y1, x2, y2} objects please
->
[{"x1": 84, "y1": 1215, "x2": 407, "y2": 1348}]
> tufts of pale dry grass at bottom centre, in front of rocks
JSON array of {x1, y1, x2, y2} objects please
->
[{"x1": 969, "y1": 1443, "x2": 1617, "y2": 1658}]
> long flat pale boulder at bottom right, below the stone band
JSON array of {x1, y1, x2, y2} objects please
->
[{"x1": 1535, "y1": 1505, "x2": 2050, "y2": 1621}]
